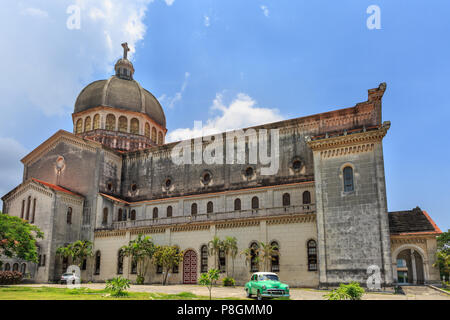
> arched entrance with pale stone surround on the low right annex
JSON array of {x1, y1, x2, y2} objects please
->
[{"x1": 392, "y1": 244, "x2": 429, "y2": 284}]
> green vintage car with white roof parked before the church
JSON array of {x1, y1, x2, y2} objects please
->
[{"x1": 244, "y1": 272, "x2": 290, "y2": 300}]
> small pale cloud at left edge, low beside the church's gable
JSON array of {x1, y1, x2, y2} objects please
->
[{"x1": 0, "y1": 137, "x2": 27, "y2": 202}]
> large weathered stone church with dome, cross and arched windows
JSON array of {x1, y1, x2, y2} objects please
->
[{"x1": 2, "y1": 44, "x2": 441, "y2": 287}]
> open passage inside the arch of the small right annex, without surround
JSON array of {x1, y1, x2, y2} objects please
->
[{"x1": 394, "y1": 248, "x2": 426, "y2": 284}]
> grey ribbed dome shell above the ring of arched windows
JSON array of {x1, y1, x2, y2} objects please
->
[{"x1": 74, "y1": 76, "x2": 166, "y2": 128}]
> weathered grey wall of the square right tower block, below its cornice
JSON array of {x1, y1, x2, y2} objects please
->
[{"x1": 314, "y1": 141, "x2": 392, "y2": 285}]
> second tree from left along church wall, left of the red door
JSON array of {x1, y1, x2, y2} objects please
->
[{"x1": 122, "y1": 234, "x2": 156, "y2": 284}]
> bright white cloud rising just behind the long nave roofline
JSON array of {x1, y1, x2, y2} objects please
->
[{"x1": 167, "y1": 93, "x2": 283, "y2": 142}]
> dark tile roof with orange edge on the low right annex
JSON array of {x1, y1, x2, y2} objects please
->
[{"x1": 389, "y1": 207, "x2": 442, "y2": 234}]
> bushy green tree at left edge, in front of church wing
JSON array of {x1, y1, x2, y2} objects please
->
[{"x1": 0, "y1": 211, "x2": 44, "y2": 266}]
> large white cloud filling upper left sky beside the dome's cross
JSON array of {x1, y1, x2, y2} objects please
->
[{"x1": 0, "y1": 0, "x2": 153, "y2": 117}]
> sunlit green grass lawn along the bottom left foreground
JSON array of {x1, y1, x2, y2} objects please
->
[{"x1": 0, "y1": 286, "x2": 232, "y2": 300}]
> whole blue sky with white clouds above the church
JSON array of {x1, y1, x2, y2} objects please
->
[{"x1": 0, "y1": 0, "x2": 450, "y2": 230}]
